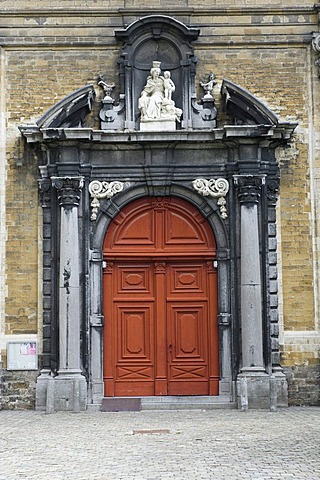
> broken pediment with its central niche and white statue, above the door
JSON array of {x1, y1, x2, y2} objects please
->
[{"x1": 20, "y1": 15, "x2": 297, "y2": 142}]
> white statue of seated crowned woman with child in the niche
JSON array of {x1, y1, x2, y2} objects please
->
[{"x1": 138, "y1": 61, "x2": 182, "y2": 131}]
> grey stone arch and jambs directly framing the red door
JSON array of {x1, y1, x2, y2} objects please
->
[{"x1": 88, "y1": 184, "x2": 234, "y2": 404}]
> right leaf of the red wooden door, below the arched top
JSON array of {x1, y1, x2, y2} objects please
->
[{"x1": 167, "y1": 262, "x2": 219, "y2": 395}]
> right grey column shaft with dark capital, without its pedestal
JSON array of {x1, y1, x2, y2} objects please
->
[{"x1": 234, "y1": 175, "x2": 265, "y2": 373}]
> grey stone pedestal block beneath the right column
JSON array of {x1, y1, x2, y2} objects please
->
[{"x1": 237, "y1": 368, "x2": 288, "y2": 411}]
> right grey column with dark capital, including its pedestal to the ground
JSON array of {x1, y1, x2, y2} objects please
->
[{"x1": 234, "y1": 175, "x2": 270, "y2": 408}]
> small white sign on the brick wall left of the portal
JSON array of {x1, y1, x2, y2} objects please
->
[{"x1": 7, "y1": 341, "x2": 38, "y2": 370}]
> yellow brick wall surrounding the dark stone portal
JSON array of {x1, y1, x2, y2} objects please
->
[{"x1": 0, "y1": 0, "x2": 320, "y2": 392}]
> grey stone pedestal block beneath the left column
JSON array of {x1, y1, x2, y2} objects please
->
[{"x1": 36, "y1": 370, "x2": 87, "y2": 413}]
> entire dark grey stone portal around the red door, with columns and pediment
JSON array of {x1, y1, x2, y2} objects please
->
[{"x1": 20, "y1": 16, "x2": 296, "y2": 411}]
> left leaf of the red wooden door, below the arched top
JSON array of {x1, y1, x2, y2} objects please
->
[{"x1": 104, "y1": 262, "x2": 155, "y2": 396}]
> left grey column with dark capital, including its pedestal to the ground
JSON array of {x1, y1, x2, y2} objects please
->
[{"x1": 50, "y1": 177, "x2": 87, "y2": 411}]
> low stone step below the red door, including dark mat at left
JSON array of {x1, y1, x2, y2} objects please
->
[{"x1": 100, "y1": 396, "x2": 236, "y2": 412}]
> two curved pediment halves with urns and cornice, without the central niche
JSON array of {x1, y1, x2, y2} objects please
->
[{"x1": 19, "y1": 79, "x2": 297, "y2": 142}]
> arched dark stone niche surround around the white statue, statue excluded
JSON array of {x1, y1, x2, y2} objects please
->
[{"x1": 115, "y1": 15, "x2": 200, "y2": 130}]
